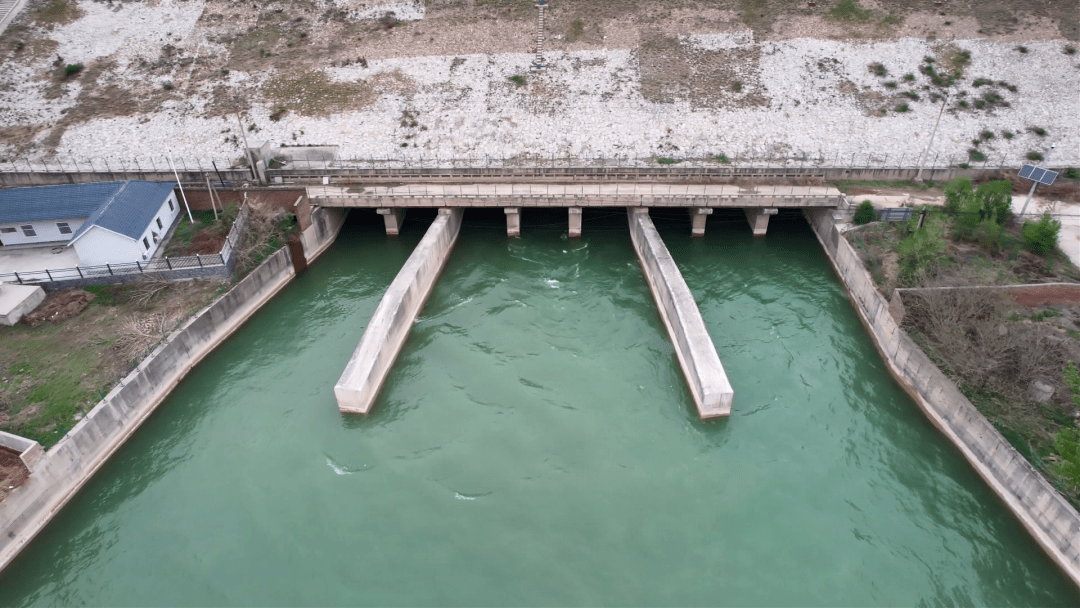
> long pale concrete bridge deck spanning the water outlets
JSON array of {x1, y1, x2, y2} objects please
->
[{"x1": 308, "y1": 183, "x2": 843, "y2": 208}]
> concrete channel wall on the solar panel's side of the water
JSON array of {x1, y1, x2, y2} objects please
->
[{"x1": 805, "y1": 211, "x2": 1080, "y2": 584}]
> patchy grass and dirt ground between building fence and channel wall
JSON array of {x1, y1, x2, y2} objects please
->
[{"x1": 0, "y1": 281, "x2": 227, "y2": 447}]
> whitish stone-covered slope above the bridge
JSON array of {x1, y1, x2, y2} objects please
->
[{"x1": 0, "y1": 0, "x2": 1080, "y2": 165}]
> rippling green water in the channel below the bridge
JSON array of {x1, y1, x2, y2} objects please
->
[{"x1": 0, "y1": 210, "x2": 1080, "y2": 606}]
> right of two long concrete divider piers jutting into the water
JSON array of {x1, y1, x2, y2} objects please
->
[{"x1": 626, "y1": 207, "x2": 734, "y2": 419}]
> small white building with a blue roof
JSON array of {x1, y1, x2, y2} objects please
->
[{"x1": 0, "y1": 181, "x2": 180, "y2": 266}]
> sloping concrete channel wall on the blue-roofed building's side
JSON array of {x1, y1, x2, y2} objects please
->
[{"x1": 0, "y1": 210, "x2": 345, "y2": 570}]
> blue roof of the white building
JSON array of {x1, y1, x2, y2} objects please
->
[{"x1": 0, "y1": 181, "x2": 173, "y2": 241}]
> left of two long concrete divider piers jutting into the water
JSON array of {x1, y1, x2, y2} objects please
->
[{"x1": 334, "y1": 208, "x2": 463, "y2": 414}]
